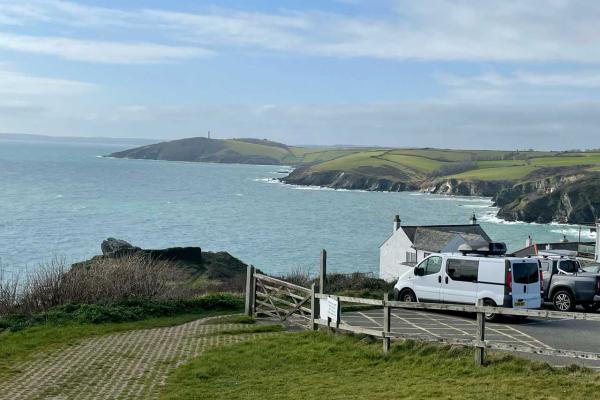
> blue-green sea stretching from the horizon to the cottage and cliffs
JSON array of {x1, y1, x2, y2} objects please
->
[{"x1": 0, "y1": 139, "x2": 593, "y2": 274}]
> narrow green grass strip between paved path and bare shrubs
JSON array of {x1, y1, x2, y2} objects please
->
[{"x1": 0, "y1": 311, "x2": 232, "y2": 380}]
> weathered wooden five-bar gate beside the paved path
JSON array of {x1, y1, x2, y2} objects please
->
[{"x1": 246, "y1": 267, "x2": 315, "y2": 328}]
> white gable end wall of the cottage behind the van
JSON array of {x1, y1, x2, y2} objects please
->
[{"x1": 379, "y1": 228, "x2": 423, "y2": 281}]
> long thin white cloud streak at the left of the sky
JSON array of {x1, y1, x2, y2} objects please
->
[{"x1": 0, "y1": 33, "x2": 212, "y2": 64}]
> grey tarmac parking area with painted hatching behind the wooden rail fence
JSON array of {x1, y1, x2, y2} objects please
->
[{"x1": 342, "y1": 310, "x2": 600, "y2": 368}]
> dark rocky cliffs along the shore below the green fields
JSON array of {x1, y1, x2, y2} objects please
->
[{"x1": 282, "y1": 167, "x2": 600, "y2": 223}]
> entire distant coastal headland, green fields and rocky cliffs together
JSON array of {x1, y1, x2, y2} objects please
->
[{"x1": 111, "y1": 138, "x2": 600, "y2": 223}]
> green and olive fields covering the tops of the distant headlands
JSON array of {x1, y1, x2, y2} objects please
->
[{"x1": 113, "y1": 138, "x2": 600, "y2": 184}]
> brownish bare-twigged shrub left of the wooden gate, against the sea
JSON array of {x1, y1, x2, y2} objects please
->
[{"x1": 0, "y1": 253, "x2": 193, "y2": 315}]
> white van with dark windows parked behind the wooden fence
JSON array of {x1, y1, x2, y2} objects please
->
[{"x1": 394, "y1": 254, "x2": 542, "y2": 321}]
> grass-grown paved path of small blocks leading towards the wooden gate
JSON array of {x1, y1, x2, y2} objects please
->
[{"x1": 0, "y1": 318, "x2": 272, "y2": 400}]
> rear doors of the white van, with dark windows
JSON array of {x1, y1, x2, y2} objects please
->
[{"x1": 511, "y1": 259, "x2": 542, "y2": 308}]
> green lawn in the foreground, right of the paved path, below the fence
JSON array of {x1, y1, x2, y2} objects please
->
[{"x1": 161, "y1": 333, "x2": 600, "y2": 400}]
